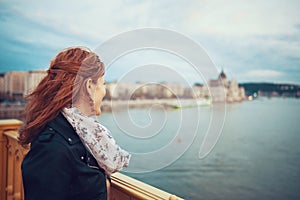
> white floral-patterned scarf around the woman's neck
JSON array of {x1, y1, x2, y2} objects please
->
[{"x1": 62, "y1": 107, "x2": 131, "y2": 175}]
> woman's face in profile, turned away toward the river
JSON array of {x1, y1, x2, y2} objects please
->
[{"x1": 92, "y1": 76, "x2": 106, "y2": 115}]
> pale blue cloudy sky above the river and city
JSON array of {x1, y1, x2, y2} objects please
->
[{"x1": 0, "y1": 0, "x2": 300, "y2": 84}]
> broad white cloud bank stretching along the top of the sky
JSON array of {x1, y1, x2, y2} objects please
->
[{"x1": 2, "y1": 0, "x2": 300, "y2": 47}]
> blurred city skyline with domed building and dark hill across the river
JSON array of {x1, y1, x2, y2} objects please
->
[{"x1": 0, "y1": 71, "x2": 300, "y2": 102}]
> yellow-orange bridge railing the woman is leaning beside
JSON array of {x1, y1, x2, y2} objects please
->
[{"x1": 0, "y1": 119, "x2": 181, "y2": 200}]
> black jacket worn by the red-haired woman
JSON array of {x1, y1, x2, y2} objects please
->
[{"x1": 22, "y1": 114, "x2": 107, "y2": 200}]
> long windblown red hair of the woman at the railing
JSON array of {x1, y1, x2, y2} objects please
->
[{"x1": 18, "y1": 47, "x2": 104, "y2": 147}]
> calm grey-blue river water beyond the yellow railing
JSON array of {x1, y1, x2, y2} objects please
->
[{"x1": 99, "y1": 98, "x2": 300, "y2": 200}]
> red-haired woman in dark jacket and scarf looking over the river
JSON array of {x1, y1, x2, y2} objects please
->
[{"x1": 19, "y1": 47, "x2": 130, "y2": 200}]
